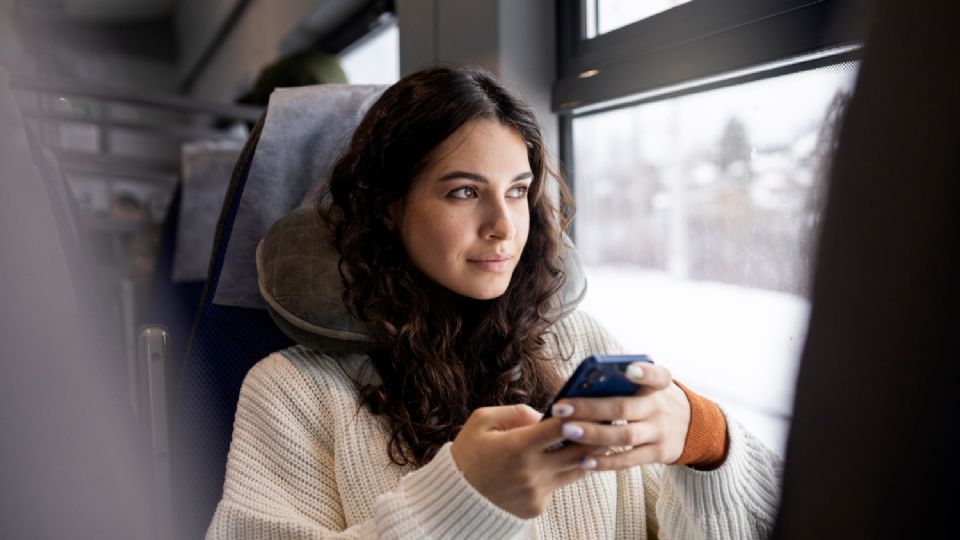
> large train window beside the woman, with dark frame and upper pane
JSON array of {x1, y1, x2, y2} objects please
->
[{"x1": 553, "y1": 0, "x2": 862, "y2": 455}]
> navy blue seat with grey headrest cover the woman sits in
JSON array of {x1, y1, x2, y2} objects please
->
[{"x1": 174, "y1": 85, "x2": 383, "y2": 538}]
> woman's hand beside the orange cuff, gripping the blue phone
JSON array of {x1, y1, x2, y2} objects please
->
[{"x1": 552, "y1": 362, "x2": 690, "y2": 470}]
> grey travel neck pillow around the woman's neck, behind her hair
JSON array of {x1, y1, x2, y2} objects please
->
[{"x1": 256, "y1": 207, "x2": 587, "y2": 353}]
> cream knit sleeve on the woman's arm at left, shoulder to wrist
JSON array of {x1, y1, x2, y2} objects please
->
[{"x1": 207, "y1": 354, "x2": 527, "y2": 540}]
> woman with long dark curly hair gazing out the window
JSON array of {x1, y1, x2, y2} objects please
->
[{"x1": 208, "y1": 68, "x2": 780, "y2": 538}]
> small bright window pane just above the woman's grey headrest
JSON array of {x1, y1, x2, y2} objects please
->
[{"x1": 340, "y1": 18, "x2": 400, "y2": 84}]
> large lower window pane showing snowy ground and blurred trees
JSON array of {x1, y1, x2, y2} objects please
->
[{"x1": 573, "y1": 64, "x2": 856, "y2": 453}]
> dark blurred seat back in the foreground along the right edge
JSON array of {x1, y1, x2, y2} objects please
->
[{"x1": 775, "y1": 0, "x2": 960, "y2": 538}]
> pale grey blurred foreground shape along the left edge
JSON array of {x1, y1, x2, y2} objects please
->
[{"x1": 0, "y1": 68, "x2": 154, "y2": 539}]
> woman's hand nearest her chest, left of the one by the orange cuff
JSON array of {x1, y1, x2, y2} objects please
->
[{"x1": 451, "y1": 405, "x2": 607, "y2": 519}]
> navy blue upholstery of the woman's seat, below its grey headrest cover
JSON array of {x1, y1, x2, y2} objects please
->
[{"x1": 174, "y1": 119, "x2": 292, "y2": 539}]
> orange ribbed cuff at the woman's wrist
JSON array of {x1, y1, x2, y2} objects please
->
[{"x1": 673, "y1": 380, "x2": 729, "y2": 470}]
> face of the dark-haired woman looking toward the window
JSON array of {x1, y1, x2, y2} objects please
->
[{"x1": 389, "y1": 120, "x2": 533, "y2": 300}]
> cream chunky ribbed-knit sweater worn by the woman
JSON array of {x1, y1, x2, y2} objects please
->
[{"x1": 207, "y1": 312, "x2": 781, "y2": 539}]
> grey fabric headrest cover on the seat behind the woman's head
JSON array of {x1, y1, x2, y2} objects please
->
[{"x1": 213, "y1": 84, "x2": 386, "y2": 309}]
